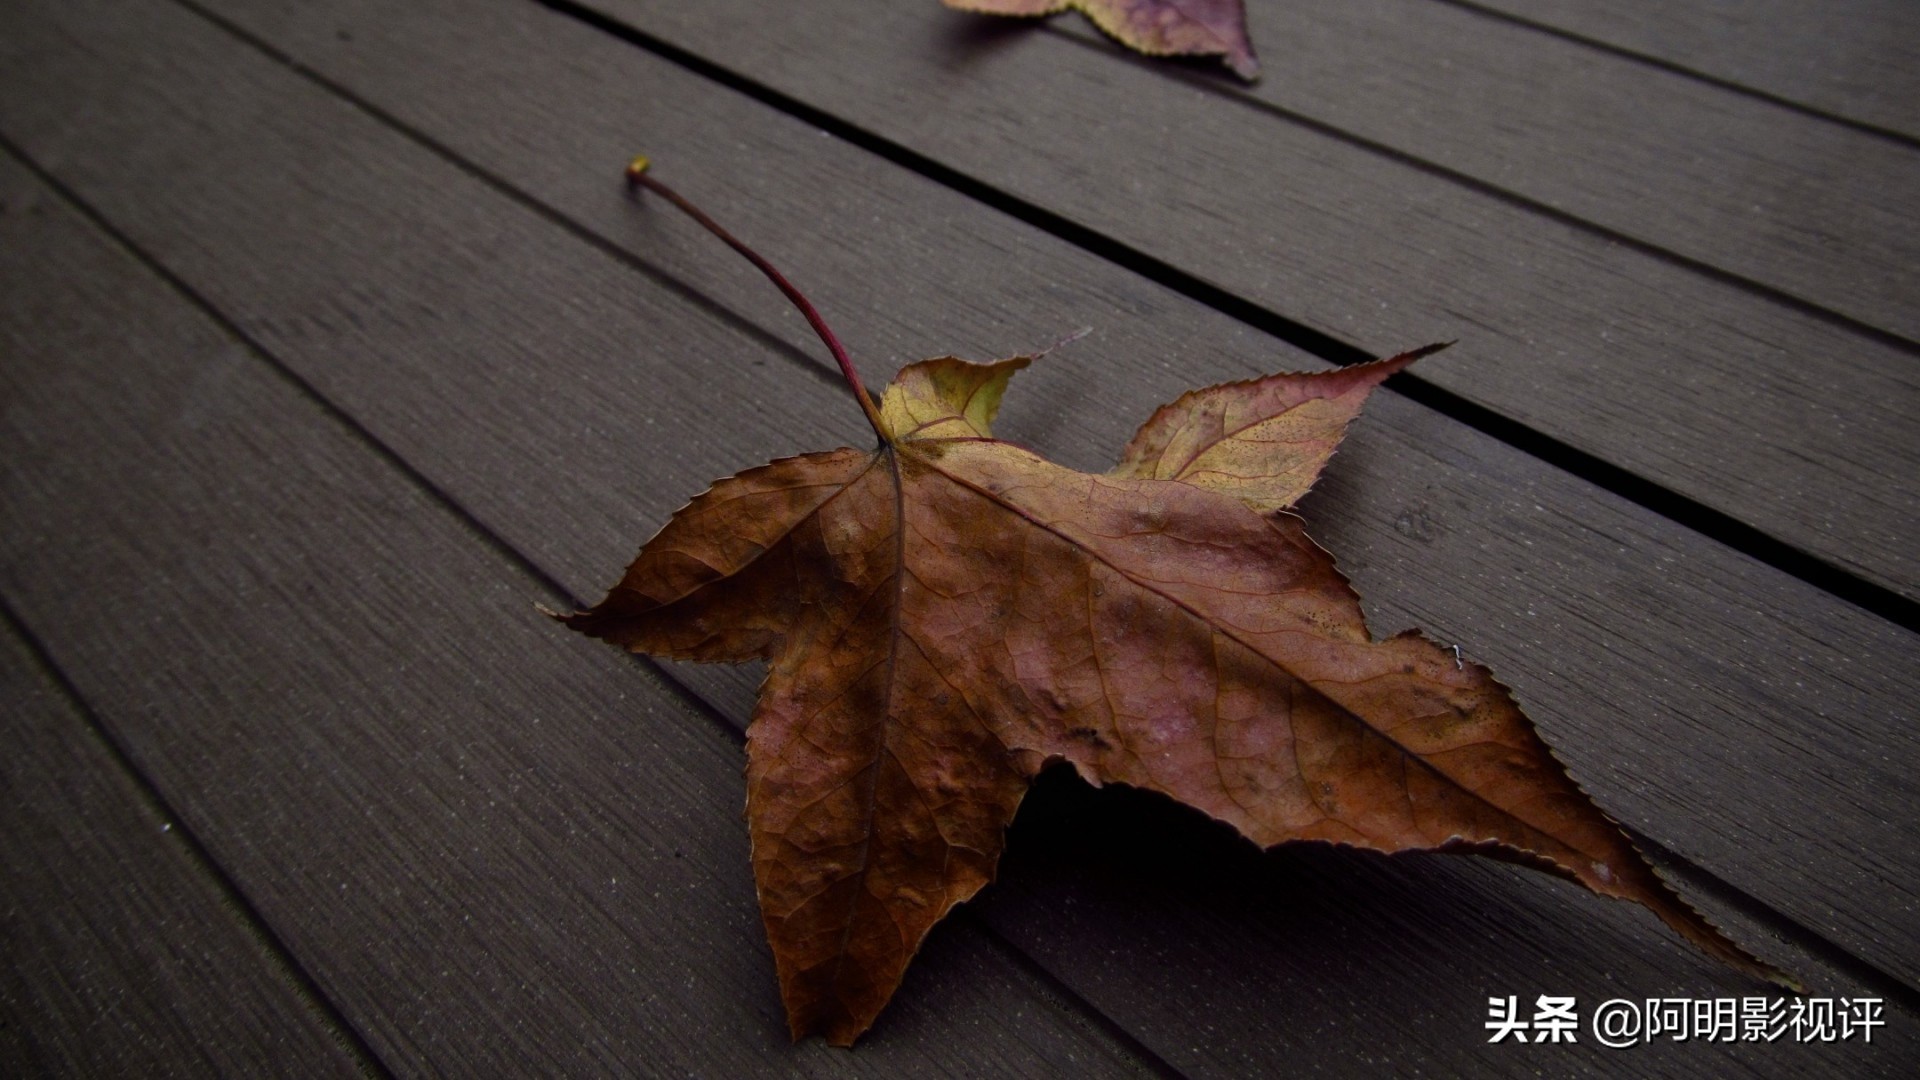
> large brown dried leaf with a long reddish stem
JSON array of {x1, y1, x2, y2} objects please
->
[{"x1": 564, "y1": 155, "x2": 1786, "y2": 1045}]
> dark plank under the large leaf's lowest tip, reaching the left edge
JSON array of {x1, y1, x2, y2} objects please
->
[{"x1": 0, "y1": 130, "x2": 1140, "y2": 1076}]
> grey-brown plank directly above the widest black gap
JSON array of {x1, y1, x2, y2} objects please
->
[{"x1": 560, "y1": 0, "x2": 1920, "y2": 598}]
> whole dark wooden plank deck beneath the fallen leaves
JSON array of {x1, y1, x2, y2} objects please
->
[{"x1": 0, "y1": 0, "x2": 1920, "y2": 1078}]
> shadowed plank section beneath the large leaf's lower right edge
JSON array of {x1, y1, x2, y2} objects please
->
[{"x1": 983, "y1": 778, "x2": 1920, "y2": 1078}]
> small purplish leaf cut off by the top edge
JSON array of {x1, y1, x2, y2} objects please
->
[{"x1": 941, "y1": 0, "x2": 1260, "y2": 83}]
